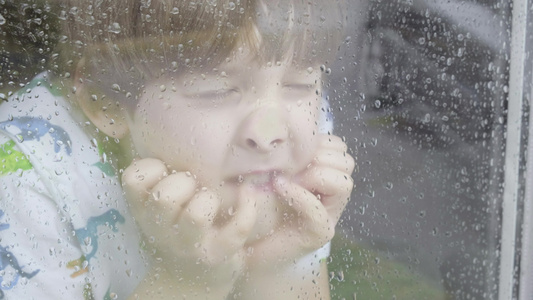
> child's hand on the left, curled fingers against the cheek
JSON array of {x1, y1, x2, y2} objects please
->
[{"x1": 122, "y1": 158, "x2": 256, "y2": 287}]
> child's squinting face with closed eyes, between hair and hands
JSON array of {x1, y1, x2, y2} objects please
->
[{"x1": 129, "y1": 54, "x2": 321, "y2": 231}]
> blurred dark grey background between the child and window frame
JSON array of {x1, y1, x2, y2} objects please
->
[{"x1": 331, "y1": 0, "x2": 511, "y2": 299}]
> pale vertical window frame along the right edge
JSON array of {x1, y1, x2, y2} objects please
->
[{"x1": 498, "y1": 0, "x2": 533, "y2": 300}]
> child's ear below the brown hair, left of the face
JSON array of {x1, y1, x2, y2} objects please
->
[{"x1": 74, "y1": 60, "x2": 129, "y2": 139}]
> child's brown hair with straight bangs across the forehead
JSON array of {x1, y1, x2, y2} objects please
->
[{"x1": 59, "y1": 0, "x2": 342, "y2": 106}]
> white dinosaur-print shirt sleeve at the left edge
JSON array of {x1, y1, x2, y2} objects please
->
[{"x1": 0, "y1": 135, "x2": 90, "y2": 299}]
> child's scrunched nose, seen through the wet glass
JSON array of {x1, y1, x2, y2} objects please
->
[{"x1": 240, "y1": 106, "x2": 288, "y2": 152}]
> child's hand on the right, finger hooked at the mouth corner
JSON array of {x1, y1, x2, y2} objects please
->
[{"x1": 245, "y1": 135, "x2": 355, "y2": 267}]
